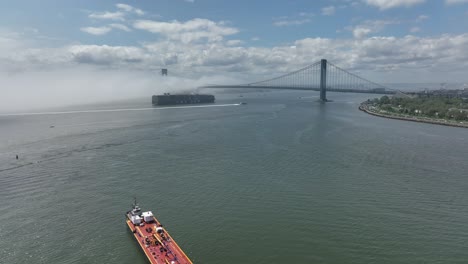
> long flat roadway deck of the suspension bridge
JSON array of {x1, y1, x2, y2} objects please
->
[{"x1": 198, "y1": 85, "x2": 396, "y2": 94}]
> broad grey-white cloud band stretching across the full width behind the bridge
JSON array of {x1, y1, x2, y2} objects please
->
[{"x1": 0, "y1": 27, "x2": 468, "y2": 111}]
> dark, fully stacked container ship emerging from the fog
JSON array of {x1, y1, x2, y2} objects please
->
[{"x1": 152, "y1": 93, "x2": 215, "y2": 105}]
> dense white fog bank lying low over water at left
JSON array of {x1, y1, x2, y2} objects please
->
[{"x1": 0, "y1": 66, "x2": 236, "y2": 113}]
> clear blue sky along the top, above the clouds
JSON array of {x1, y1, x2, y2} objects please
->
[{"x1": 0, "y1": 0, "x2": 468, "y2": 46}]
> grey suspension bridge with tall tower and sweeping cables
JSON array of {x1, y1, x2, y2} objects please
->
[{"x1": 199, "y1": 59, "x2": 397, "y2": 102}]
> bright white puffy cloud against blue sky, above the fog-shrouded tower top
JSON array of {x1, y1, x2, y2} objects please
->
[{"x1": 133, "y1": 18, "x2": 239, "y2": 43}]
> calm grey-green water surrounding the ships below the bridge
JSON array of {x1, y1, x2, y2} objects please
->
[{"x1": 0, "y1": 92, "x2": 468, "y2": 263}]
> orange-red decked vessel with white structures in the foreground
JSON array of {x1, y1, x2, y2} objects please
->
[{"x1": 126, "y1": 200, "x2": 192, "y2": 264}]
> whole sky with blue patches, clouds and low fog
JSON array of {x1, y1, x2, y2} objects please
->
[{"x1": 0, "y1": 0, "x2": 468, "y2": 111}]
